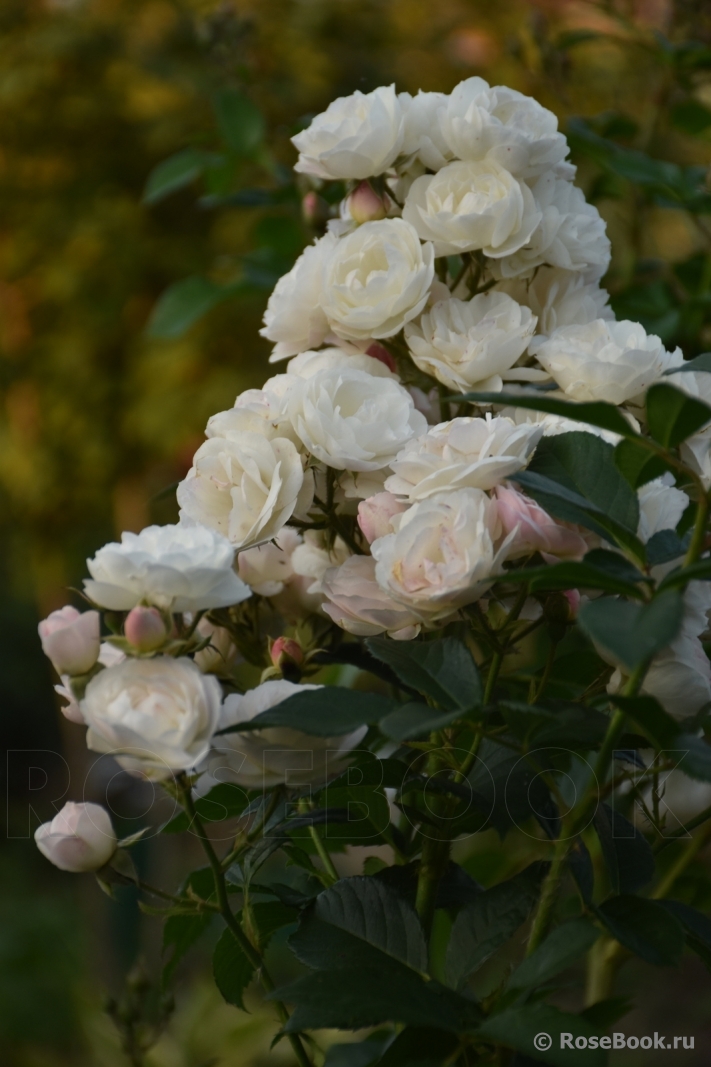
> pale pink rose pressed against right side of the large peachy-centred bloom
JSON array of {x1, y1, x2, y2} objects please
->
[{"x1": 495, "y1": 485, "x2": 587, "y2": 559}]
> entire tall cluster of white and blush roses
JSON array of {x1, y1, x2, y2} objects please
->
[{"x1": 41, "y1": 78, "x2": 711, "y2": 870}]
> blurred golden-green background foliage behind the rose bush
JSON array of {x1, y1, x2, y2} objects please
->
[{"x1": 0, "y1": 0, "x2": 711, "y2": 1067}]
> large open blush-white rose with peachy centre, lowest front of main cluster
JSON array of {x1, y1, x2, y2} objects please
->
[{"x1": 370, "y1": 489, "x2": 507, "y2": 623}]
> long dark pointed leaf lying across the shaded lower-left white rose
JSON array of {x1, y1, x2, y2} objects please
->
[{"x1": 218, "y1": 685, "x2": 398, "y2": 737}]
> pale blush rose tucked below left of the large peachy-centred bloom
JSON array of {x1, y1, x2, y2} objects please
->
[{"x1": 322, "y1": 556, "x2": 421, "y2": 641}]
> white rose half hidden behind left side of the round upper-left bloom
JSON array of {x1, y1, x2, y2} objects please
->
[{"x1": 259, "y1": 234, "x2": 337, "y2": 363}]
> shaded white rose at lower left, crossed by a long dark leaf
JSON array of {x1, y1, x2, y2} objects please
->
[{"x1": 206, "y1": 681, "x2": 367, "y2": 790}]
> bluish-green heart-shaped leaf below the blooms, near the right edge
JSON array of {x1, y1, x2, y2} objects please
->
[{"x1": 578, "y1": 589, "x2": 684, "y2": 671}]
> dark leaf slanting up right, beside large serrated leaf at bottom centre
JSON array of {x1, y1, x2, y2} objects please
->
[{"x1": 445, "y1": 864, "x2": 542, "y2": 987}]
